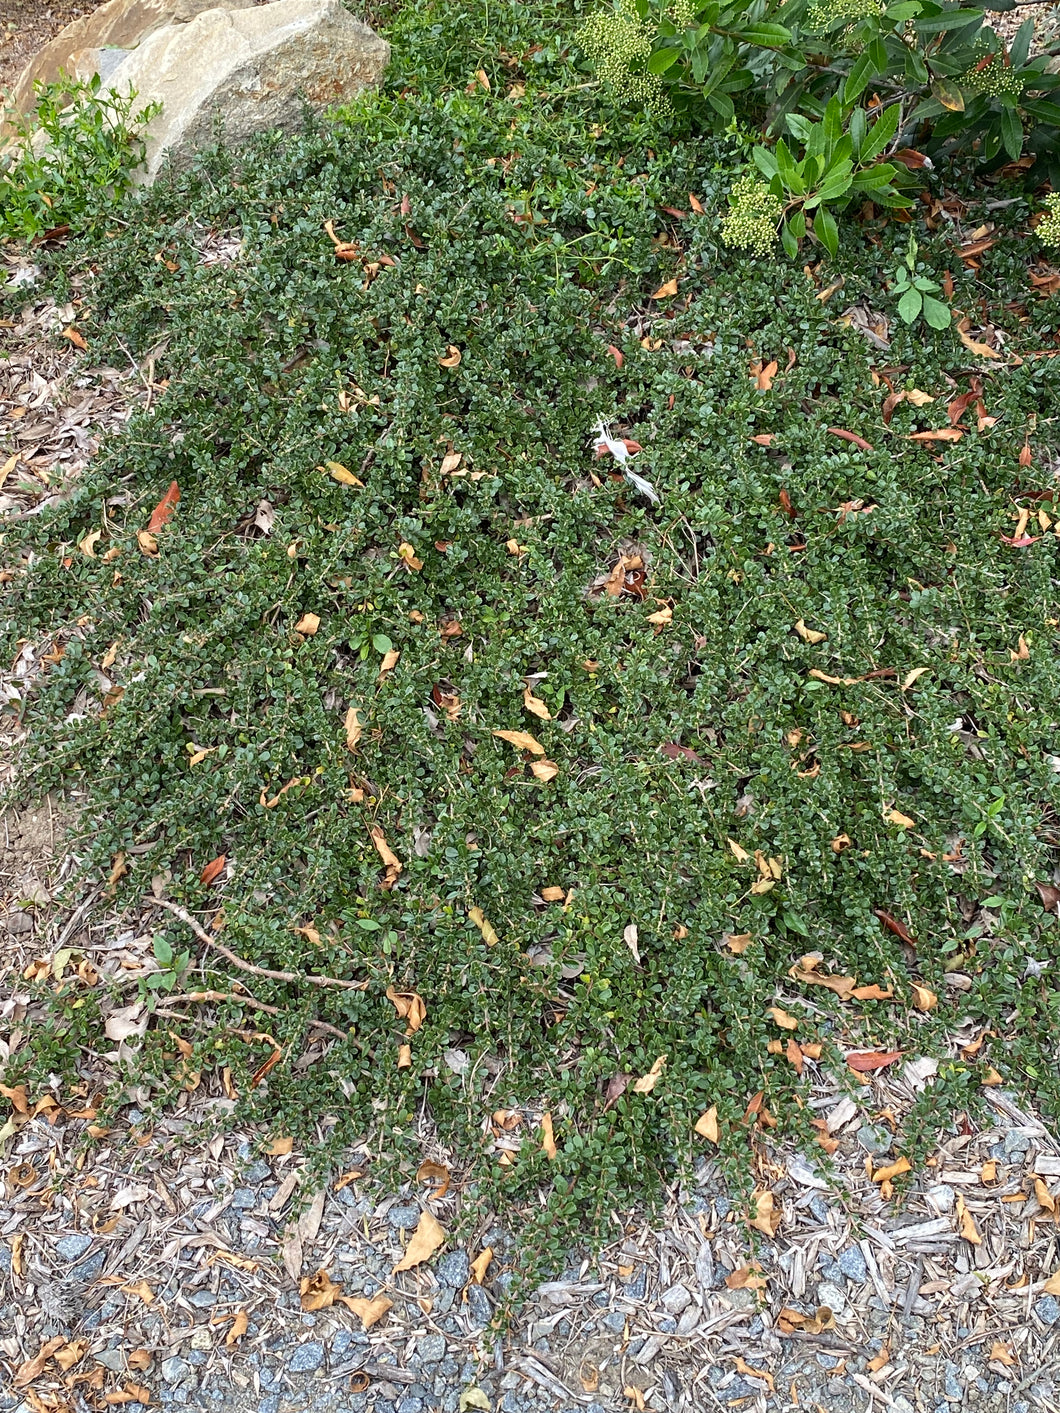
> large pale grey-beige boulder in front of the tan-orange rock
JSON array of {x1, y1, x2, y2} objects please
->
[{"x1": 99, "y1": 0, "x2": 390, "y2": 181}]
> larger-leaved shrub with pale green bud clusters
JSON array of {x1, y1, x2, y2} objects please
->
[{"x1": 581, "y1": 0, "x2": 1060, "y2": 254}]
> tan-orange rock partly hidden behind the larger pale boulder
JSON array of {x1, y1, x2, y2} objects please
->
[{"x1": 11, "y1": 0, "x2": 254, "y2": 121}]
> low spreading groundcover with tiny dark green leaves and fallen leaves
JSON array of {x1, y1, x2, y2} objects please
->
[{"x1": 3, "y1": 7, "x2": 1060, "y2": 1258}]
